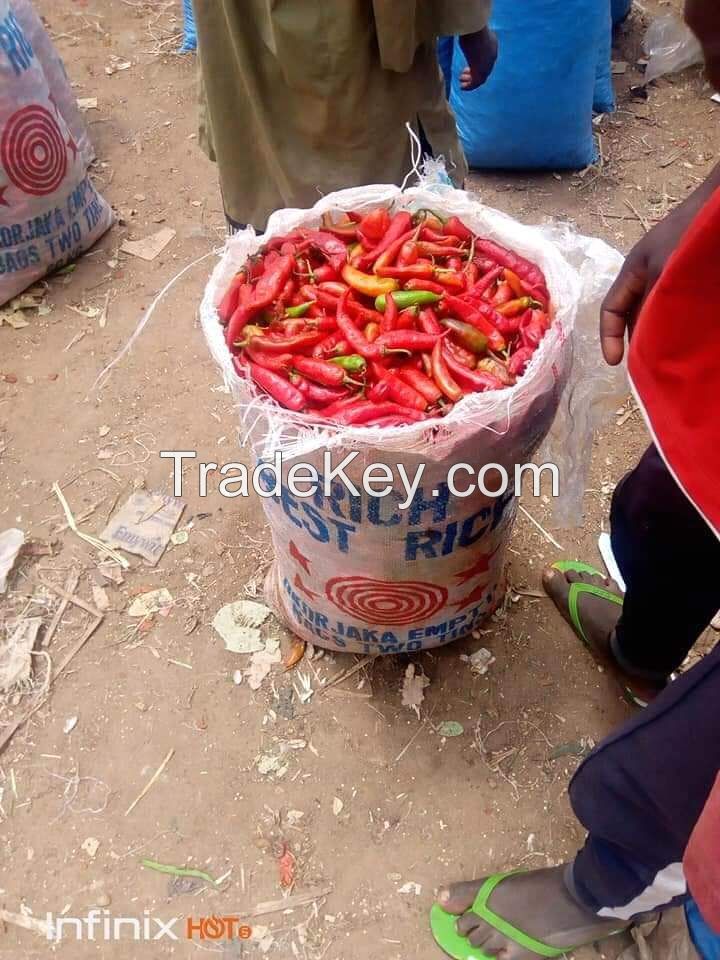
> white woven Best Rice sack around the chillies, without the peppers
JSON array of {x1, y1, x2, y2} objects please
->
[{"x1": 201, "y1": 185, "x2": 626, "y2": 653}]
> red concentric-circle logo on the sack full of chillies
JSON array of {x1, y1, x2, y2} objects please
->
[{"x1": 325, "y1": 577, "x2": 448, "y2": 626}]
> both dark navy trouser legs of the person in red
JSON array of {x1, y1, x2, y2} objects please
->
[{"x1": 570, "y1": 447, "x2": 720, "y2": 920}]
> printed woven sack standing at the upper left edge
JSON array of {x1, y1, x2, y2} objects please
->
[{"x1": 0, "y1": 0, "x2": 113, "y2": 304}]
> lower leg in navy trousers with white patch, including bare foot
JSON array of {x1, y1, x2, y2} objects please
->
[{"x1": 438, "y1": 648, "x2": 720, "y2": 960}]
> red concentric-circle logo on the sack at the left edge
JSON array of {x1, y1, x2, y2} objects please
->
[{"x1": 0, "y1": 104, "x2": 67, "y2": 197}]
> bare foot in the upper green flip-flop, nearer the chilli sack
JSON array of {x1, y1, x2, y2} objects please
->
[{"x1": 542, "y1": 567, "x2": 664, "y2": 706}]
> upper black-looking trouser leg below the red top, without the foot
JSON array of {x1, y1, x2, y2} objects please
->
[{"x1": 610, "y1": 446, "x2": 720, "y2": 679}]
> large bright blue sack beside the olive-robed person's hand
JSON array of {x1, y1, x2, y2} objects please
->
[{"x1": 450, "y1": 0, "x2": 609, "y2": 170}]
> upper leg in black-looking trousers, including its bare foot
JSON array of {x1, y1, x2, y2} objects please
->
[{"x1": 543, "y1": 447, "x2": 720, "y2": 702}]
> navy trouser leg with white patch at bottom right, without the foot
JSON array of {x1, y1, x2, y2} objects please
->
[{"x1": 569, "y1": 647, "x2": 720, "y2": 920}]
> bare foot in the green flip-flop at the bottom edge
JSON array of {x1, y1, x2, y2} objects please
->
[{"x1": 438, "y1": 866, "x2": 629, "y2": 960}]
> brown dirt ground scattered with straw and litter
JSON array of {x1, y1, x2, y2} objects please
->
[{"x1": 0, "y1": 0, "x2": 720, "y2": 960}]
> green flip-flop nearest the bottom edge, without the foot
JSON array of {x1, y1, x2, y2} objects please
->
[{"x1": 430, "y1": 870, "x2": 585, "y2": 960}]
